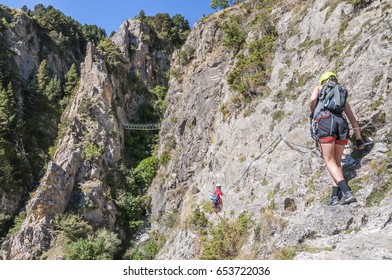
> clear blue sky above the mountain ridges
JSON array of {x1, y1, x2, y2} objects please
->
[{"x1": 0, "y1": 0, "x2": 215, "y2": 35}]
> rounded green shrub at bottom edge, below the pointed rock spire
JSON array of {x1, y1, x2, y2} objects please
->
[{"x1": 65, "y1": 229, "x2": 121, "y2": 260}]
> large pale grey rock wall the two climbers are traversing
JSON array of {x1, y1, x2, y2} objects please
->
[{"x1": 150, "y1": 1, "x2": 392, "y2": 259}]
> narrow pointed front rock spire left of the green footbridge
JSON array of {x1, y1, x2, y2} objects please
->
[{"x1": 2, "y1": 42, "x2": 121, "y2": 259}]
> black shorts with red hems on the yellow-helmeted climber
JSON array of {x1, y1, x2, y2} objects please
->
[{"x1": 313, "y1": 111, "x2": 350, "y2": 145}]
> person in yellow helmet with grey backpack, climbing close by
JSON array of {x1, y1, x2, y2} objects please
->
[{"x1": 309, "y1": 72, "x2": 365, "y2": 205}]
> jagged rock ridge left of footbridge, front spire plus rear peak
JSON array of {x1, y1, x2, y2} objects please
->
[{"x1": 1, "y1": 17, "x2": 169, "y2": 259}]
